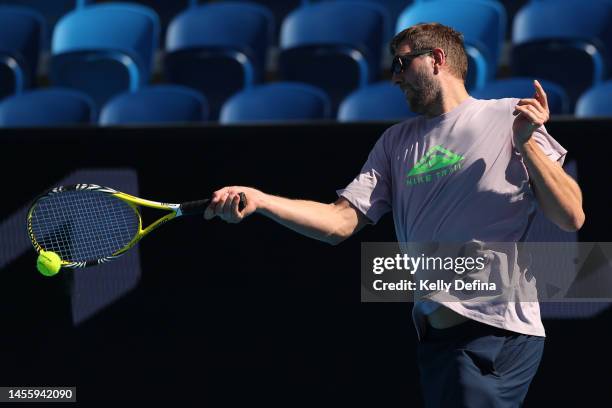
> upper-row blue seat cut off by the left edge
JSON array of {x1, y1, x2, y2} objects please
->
[{"x1": 0, "y1": 5, "x2": 45, "y2": 87}]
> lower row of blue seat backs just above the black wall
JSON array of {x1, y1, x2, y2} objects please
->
[{"x1": 0, "y1": 79, "x2": 612, "y2": 127}]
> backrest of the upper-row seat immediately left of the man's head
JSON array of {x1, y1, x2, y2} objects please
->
[{"x1": 280, "y1": 1, "x2": 387, "y2": 72}]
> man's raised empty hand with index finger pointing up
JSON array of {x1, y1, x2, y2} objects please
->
[{"x1": 512, "y1": 80, "x2": 550, "y2": 146}]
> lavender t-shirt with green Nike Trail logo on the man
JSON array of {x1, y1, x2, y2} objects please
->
[{"x1": 338, "y1": 97, "x2": 567, "y2": 337}]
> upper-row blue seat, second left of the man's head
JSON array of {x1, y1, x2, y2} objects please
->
[{"x1": 164, "y1": 2, "x2": 273, "y2": 119}]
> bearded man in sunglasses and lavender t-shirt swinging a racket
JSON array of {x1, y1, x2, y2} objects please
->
[{"x1": 205, "y1": 23, "x2": 585, "y2": 407}]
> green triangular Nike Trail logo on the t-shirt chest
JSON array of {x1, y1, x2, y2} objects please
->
[{"x1": 406, "y1": 145, "x2": 463, "y2": 185}]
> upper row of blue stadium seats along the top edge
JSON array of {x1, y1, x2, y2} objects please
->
[{"x1": 0, "y1": 0, "x2": 612, "y2": 119}]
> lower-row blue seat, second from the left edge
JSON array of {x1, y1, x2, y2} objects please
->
[{"x1": 99, "y1": 85, "x2": 208, "y2": 126}]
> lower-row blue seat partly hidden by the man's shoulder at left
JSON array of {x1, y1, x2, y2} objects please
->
[{"x1": 338, "y1": 81, "x2": 416, "y2": 122}]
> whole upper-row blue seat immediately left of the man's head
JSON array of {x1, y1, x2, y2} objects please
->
[{"x1": 279, "y1": 1, "x2": 386, "y2": 107}]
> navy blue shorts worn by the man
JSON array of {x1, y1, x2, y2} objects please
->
[{"x1": 418, "y1": 320, "x2": 544, "y2": 408}]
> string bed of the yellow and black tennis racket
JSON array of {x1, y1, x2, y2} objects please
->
[{"x1": 32, "y1": 191, "x2": 139, "y2": 262}]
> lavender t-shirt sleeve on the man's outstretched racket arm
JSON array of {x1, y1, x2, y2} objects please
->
[{"x1": 336, "y1": 132, "x2": 392, "y2": 224}]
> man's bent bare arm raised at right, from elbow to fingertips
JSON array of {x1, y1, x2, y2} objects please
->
[{"x1": 512, "y1": 81, "x2": 585, "y2": 231}]
